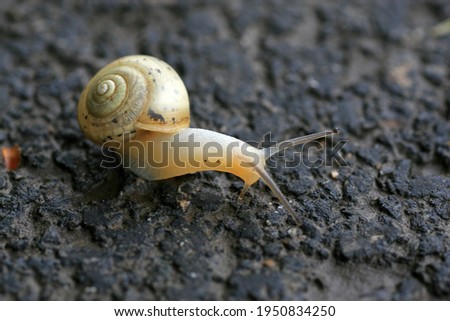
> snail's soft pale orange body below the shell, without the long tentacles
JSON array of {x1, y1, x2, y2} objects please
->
[{"x1": 118, "y1": 128, "x2": 265, "y2": 185}]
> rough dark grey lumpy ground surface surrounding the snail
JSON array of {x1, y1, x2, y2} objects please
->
[{"x1": 0, "y1": 0, "x2": 450, "y2": 300}]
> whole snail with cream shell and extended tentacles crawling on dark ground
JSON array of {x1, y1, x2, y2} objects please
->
[{"x1": 78, "y1": 55, "x2": 338, "y2": 223}]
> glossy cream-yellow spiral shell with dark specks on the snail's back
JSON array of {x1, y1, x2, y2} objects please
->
[{"x1": 78, "y1": 56, "x2": 189, "y2": 144}]
